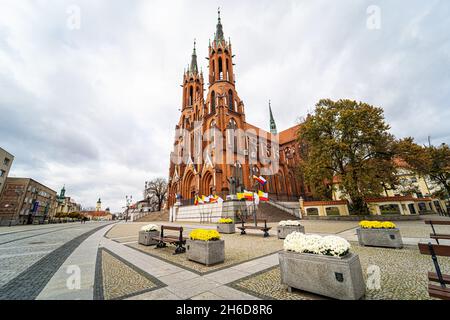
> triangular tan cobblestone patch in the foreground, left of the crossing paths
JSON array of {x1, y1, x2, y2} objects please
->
[{"x1": 98, "y1": 249, "x2": 163, "y2": 300}]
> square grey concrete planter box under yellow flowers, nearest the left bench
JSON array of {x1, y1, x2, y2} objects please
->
[{"x1": 186, "y1": 239, "x2": 225, "y2": 266}]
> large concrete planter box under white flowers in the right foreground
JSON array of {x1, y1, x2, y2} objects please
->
[{"x1": 279, "y1": 251, "x2": 366, "y2": 300}]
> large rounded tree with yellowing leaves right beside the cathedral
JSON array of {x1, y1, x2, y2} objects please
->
[{"x1": 299, "y1": 99, "x2": 397, "y2": 214}]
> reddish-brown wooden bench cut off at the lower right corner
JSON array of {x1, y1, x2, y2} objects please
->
[{"x1": 419, "y1": 242, "x2": 450, "y2": 300}]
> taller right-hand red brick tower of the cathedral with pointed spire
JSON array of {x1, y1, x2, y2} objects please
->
[{"x1": 204, "y1": 9, "x2": 249, "y2": 194}]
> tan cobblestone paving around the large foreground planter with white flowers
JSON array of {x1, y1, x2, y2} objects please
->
[{"x1": 231, "y1": 244, "x2": 450, "y2": 300}]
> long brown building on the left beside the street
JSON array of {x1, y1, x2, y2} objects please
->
[{"x1": 0, "y1": 178, "x2": 57, "y2": 225}]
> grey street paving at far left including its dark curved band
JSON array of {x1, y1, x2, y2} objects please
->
[{"x1": 0, "y1": 222, "x2": 113, "y2": 299}]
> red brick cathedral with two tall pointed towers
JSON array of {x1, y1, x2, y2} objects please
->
[{"x1": 168, "y1": 12, "x2": 306, "y2": 207}]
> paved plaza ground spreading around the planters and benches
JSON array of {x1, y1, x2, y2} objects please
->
[{"x1": 0, "y1": 220, "x2": 450, "y2": 300}]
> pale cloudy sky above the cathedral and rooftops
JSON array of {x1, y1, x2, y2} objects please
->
[{"x1": 0, "y1": 0, "x2": 450, "y2": 211}]
